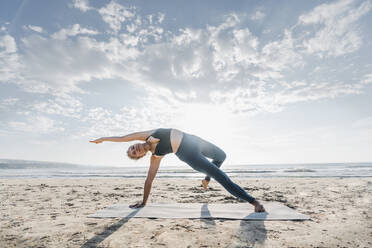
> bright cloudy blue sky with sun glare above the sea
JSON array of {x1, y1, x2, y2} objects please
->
[{"x1": 0, "y1": 0, "x2": 372, "y2": 166}]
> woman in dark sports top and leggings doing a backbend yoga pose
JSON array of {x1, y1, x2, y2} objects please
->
[{"x1": 90, "y1": 128, "x2": 265, "y2": 212}]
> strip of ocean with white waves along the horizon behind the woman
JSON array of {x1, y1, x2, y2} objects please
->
[{"x1": 0, "y1": 159, "x2": 372, "y2": 179}]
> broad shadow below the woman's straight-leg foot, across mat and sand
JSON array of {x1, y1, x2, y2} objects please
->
[{"x1": 239, "y1": 212, "x2": 267, "y2": 247}]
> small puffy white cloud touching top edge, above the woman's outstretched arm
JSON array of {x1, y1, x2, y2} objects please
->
[{"x1": 98, "y1": 1, "x2": 135, "y2": 33}]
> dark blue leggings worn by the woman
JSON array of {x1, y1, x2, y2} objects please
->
[{"x1": 176, "y1": 133, "x2": 255, "y2": 203}]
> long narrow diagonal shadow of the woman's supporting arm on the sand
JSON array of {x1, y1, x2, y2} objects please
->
[{"x1": 80, "y1": 208, "x2": 141, "y2": 248}]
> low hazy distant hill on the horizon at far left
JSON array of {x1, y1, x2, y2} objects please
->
[{"x1": 0, "y1": 159, "x2": 89, "y2": 169}]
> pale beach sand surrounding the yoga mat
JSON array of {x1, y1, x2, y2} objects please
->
[{"x1": 0, "y1": 178, "x2": 372, "y2": 248}]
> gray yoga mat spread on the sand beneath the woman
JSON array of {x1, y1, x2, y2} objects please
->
[{"x1": 88, "y1": 202, "x2": 310, "y2": 220}]
